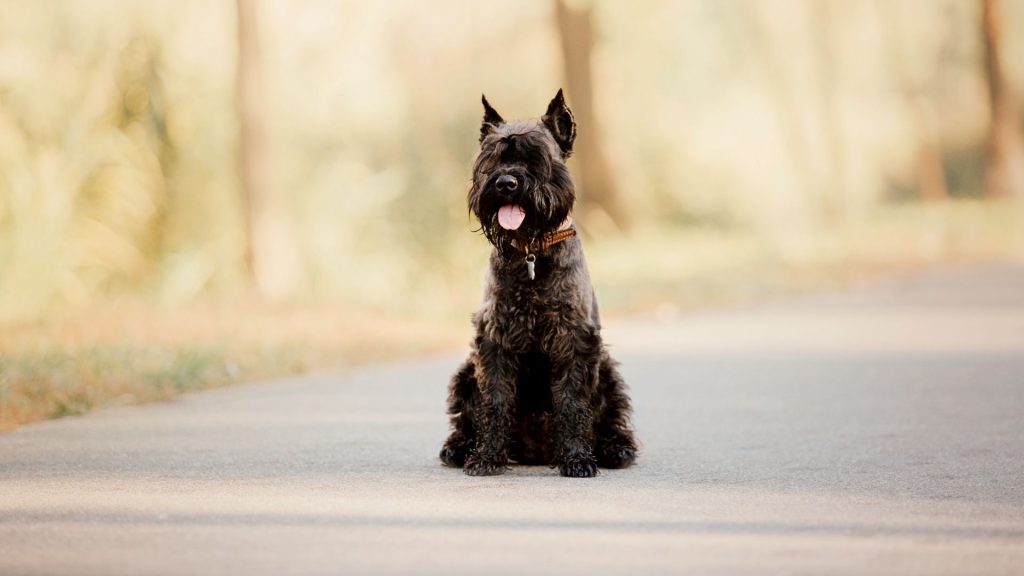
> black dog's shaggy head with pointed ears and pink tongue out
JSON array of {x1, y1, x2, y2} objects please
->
[{"x1": 469, "y1": 90, "x2": 575, "y2": 249}]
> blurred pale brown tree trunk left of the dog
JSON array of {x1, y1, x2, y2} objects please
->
[{"x1": 236, "y1": 0, "x2": 299, "y2": 300}]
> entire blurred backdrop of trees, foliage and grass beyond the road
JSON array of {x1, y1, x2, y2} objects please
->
[{"x1": 0, "y1": 0, "x2": 1024, "y2": 427}]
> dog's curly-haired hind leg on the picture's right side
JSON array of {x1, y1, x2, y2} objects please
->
[{"x1": 594, "y1": 351, "x2": 637, "y2": 468}]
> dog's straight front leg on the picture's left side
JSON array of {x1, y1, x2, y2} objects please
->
[{"x1": 463, "y1": 339, "x2": 518, "y2": 476}]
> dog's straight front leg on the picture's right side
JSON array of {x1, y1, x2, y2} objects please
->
[{"x1": 551, "y1": 355, "x2": 598, "y2": 478}]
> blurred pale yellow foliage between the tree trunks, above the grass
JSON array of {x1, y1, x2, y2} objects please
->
[{"x1": 0, "y1": 0, "x2": 1024, "y2": 320}]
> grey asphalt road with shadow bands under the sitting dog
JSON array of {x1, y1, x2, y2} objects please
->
[{"x1": 0, "y1": 265, "x2": 1024, "y2": 575}]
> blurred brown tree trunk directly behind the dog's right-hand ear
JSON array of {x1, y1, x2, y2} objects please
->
[{"x1": 555, "y1": 0, "x2": 629, "y2": 229}]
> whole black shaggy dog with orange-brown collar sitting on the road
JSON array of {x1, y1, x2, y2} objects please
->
[{"x1": 440, "y1": 90, "x2": 637, "y2": 478}]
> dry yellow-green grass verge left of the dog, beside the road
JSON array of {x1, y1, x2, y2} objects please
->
[{"x1": 0, "y1": 302, "x2": 459, "y2": 430}]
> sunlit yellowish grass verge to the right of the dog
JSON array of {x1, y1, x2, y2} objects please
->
[{"x1": 588, "y1": 200, "x2": 1024, "y2": 313}]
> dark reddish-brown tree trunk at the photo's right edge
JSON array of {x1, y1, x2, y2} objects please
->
[{"x1": 981, "y1": 0, "x2": 1024, "y2": 199}]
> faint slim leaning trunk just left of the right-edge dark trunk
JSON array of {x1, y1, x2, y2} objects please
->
[{"x1": 874, "y1": 0, "x2": 949, "y2": 201}]
